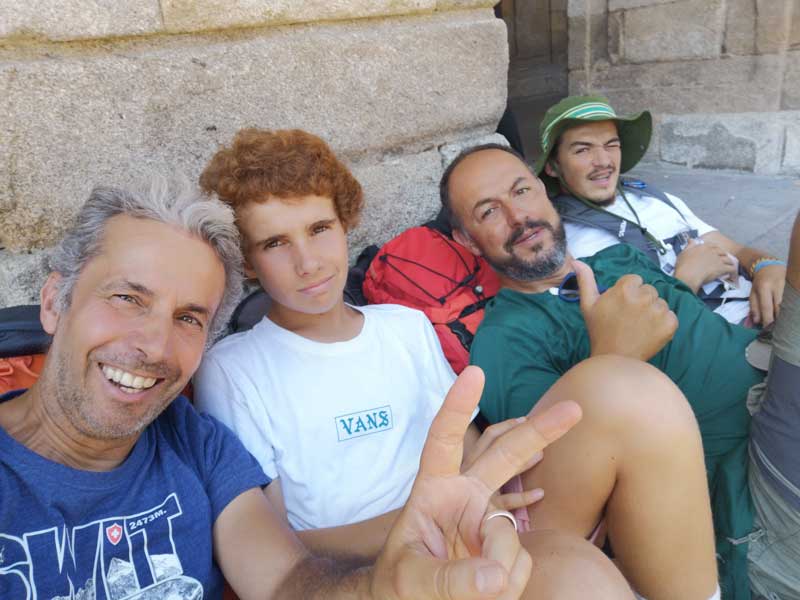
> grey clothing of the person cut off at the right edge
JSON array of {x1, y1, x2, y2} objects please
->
[{"x1": 748, "y1": 283, "x2": 800, "y2": 600}]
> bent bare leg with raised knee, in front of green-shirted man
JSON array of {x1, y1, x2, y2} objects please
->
[{"x1": 523, "y1": 356, "x2": 717, "y2": 600}]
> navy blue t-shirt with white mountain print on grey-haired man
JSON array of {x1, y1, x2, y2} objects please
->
[{"x1": 0, "y1": 392, "x2": 269, "y2": 600}]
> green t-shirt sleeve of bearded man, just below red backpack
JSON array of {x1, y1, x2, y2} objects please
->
[{"x1": 470, "y1": 327, "x2": 562, "y2": 423}]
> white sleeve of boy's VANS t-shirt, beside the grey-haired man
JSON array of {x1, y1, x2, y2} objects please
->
[{"x1": 193, "y1": 355, "x2": 278, "y2": 479}]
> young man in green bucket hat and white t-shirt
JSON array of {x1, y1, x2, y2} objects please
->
[{"x1": 534, "y1": 96, "x2": 786, "y2": 326}]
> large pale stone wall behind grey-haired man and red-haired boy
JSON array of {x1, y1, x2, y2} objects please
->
[{"x1": 0, "y1": 0, "x2": 508, "y2": 306}]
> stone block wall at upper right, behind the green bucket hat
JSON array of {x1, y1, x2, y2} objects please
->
[{"x1": 567, "y1": 0, "x2": 800, "y2": 175}]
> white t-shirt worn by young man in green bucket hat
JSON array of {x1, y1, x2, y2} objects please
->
[{"x1": 564, "y1": 190, "x2": 750, "y2": 323}]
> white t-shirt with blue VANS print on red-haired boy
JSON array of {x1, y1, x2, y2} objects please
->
[{"x1": 194, "y1": 305, "x2": 455, "y2": 529}]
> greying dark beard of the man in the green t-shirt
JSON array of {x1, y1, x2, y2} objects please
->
[{"x1": 484, "y1": 220, "x2": 567, "y2": 281}]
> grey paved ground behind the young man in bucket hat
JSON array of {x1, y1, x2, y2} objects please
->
[{"x1": 630, "y1": 165, "x2": 800, "y2": 259}]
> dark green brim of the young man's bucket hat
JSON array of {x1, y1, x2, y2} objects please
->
[{"x1": 533, "y1": 110, "x2": 653, "y2": 196}]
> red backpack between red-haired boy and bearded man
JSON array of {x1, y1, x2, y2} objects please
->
[{"x1": 363, "y1": 226, "x2": 500, "y2": 373}]
